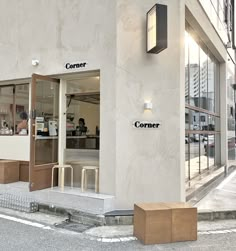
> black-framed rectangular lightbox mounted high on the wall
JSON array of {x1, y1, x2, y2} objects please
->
[{"x1": 146, "y1": 4, "x2": 167, "y2": 54}]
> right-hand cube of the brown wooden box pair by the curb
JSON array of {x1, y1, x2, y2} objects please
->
[{"x1": 165, "y1": 202, "x2": 197, "y2": 242}]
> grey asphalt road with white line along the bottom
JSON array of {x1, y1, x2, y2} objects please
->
[{"x1": 0, "y1": 211, "x2": 236, "y2": 251}]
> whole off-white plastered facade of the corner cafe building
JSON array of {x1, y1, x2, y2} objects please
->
[{"x1": 0, "y1": 0, "x2": 235, "y2": 209}]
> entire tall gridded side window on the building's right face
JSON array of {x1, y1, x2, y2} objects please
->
[{"x1": 185, "y1": 27, "x2": 220, "y2": 180}]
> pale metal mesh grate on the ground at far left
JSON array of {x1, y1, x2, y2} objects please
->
[{"x1": 0, "y1": 193, "x2": 38, "y2": 213}]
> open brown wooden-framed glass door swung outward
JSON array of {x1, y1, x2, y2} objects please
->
[{"x1": 29, "y1": 74, "x2": 59, "y2": 191}]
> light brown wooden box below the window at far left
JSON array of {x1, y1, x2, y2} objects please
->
[{"x1": 0, "y1": 160, "x2": 19, "y2": 184}]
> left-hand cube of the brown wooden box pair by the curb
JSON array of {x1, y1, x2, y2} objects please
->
[{"x1": 134, "y1": 203, "x2": 172, "y2": 244}]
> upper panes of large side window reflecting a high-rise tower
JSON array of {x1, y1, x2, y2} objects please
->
[{"x1": 185, "y1": 28, "x2": 216, "y2": 112}]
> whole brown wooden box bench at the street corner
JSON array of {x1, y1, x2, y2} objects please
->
[{"x1": 134, "y1": 202, "x2": 197, "y2": 244}]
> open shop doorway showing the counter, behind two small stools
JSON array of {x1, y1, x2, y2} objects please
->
[{"x1": 61, "y1": 71, "x2": 100, "y2": 192}]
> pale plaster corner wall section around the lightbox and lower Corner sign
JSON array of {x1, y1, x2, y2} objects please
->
[{"x1": 116, "y1": 0, "x2": 185, "y2": 208}]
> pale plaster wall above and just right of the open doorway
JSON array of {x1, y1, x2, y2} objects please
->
[{"x1": 0, "y1": 0, "x2": 116, "y2": 194}]
